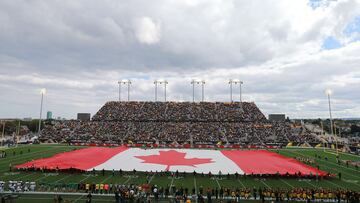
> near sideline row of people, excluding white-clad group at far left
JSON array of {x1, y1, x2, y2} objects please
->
[{"x1": 40, "y1": 183, "x2": 360, "y2": 202}]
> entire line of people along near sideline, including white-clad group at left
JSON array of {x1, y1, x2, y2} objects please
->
[{"x1": 0, "y1": 181, "x2": 360, "y2": 201}]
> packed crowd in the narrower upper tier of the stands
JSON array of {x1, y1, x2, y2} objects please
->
[{"x1": 93, "y1": 101, "x2": 266, "y2": 122}]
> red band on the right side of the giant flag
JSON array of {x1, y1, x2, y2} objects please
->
[{"x1": 221, "y1": 150, "x2": 326, "y2": 176}]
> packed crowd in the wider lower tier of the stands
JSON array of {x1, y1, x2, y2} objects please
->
[{"x1": 40, "y1": 120, "x2": 315, "y2": 145}]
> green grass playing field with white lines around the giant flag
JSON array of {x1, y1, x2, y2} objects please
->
[{"x1": 0, "y1": 145, "x2": 360, "y2": 202}]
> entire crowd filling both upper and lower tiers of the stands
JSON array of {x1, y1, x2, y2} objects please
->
[{"x1": 40, "y1": 102, "x2": 316, "y2": 145}]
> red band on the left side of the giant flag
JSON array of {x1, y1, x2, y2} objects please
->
[{"x1": 16, "y1": 146, "x2": 128, "y2": 170}]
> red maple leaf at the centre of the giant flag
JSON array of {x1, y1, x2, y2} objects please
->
[{"x1": 135, "y1": 150, "x2": 213, "y2": 171}]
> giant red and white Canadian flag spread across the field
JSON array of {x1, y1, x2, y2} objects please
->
[{"x1": 16, "y1": 147, "x2": 326, "y2": 176}]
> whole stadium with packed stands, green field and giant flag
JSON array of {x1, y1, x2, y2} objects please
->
[{"x1": 1, "y1": 101, "x2": 360, "y2": 202}]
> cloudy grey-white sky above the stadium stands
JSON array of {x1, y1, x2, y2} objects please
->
[{"x1": 0, "y1": 0, "x2": 360, "y2": 118}]
